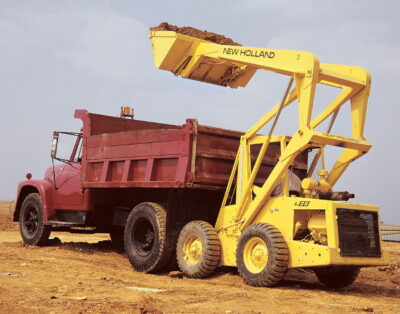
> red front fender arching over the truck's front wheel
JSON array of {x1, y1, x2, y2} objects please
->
[{"x1": 13, "y1": 180, "x2": 54, "y2": 223}]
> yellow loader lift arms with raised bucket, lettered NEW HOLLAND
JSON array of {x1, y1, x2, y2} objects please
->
[{"x1": 150, "y1": 31, "x2": 371, "y2": 231}]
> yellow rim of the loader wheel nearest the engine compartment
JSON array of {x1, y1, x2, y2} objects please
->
[{"x1": 243, "y1": 237, "x2": 268, "y2": 274}]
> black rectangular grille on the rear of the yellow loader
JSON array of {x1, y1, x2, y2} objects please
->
[{"x1": 336, "y1": 208, "x2": 381, "y2": 257}]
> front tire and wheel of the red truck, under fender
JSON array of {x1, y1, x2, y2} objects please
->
[{"x1": 19, "y1": 193, "x2": 51, "y2": 246}]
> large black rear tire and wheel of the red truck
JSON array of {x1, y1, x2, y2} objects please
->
[{"x1": 124, "y1": 203, "x2": 174, "y2": 273}]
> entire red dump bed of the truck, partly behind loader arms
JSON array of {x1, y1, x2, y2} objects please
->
[{"x1": 75, "y1": 110, "x2": 307, "y2": 190}]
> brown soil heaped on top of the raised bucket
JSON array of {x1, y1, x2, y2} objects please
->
[{"x1": 150, "y1": 22, "x2": 241, "y2": 46}]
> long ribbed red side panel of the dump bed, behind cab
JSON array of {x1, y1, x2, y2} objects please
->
[{"x1": 78, "y1": 114, "x2": 193, "y2": 188}]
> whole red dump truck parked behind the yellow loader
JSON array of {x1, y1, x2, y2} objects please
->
[{"x1": 13, "y1": 108, "x2": 307, "y2": 272}]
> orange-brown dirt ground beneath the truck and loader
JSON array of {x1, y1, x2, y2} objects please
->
[{"x1": 0, "y1": 204, "x2": 400, "y2": 313}]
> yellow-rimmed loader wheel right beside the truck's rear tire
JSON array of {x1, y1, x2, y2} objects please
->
[{"x1": 176, "y1": 220, "x2": 221, "y2": 278}]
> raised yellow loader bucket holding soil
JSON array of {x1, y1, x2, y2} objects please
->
[{"x1": 150, "y1": 30, "x2": 256, "y2": 88}]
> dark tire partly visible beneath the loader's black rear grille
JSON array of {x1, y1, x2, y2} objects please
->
[{"x1": 314, "y1": 266, "x2": 360, "y2": 288}]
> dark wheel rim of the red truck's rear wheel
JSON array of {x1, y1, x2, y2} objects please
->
[{"x1": 132, "y1": 219, "x2": 155, "y2": 257}]
